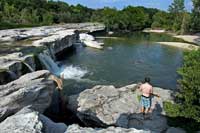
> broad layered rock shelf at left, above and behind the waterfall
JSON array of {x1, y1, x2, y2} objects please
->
[{"x1": 0, "y1": 23, "x2": 105, "y2": 82}]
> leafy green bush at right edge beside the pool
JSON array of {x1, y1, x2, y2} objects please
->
[{"x1": 178, "y1": 50, "x2": 200, "y2": 122}]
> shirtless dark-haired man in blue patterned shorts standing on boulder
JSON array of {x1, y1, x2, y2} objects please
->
[{"x1": 138, "y1": 77, "x2": 160, "y2": 115}]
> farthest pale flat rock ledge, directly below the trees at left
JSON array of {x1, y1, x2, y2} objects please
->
[{"x1": 0, "y1": 23, "x2": 105, "y2": 41}]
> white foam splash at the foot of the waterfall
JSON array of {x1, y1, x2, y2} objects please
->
[{"x1": 60, "y1": 65, "x2": 88, "y2": 80}]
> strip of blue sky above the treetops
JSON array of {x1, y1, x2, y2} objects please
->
[{"x1": 62, "y1": 0, "x2": 192, "y2": 11}]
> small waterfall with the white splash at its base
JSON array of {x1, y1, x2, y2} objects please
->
[{"x1": 39, "y1": 53, "x2": 87, "y2": 80}]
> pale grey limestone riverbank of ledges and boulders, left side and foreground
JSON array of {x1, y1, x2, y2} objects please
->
[{"x1": 0, "y1": 23, "x2": 186, "y2": 133}]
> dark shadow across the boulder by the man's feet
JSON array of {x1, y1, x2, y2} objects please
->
[{"x1": 116, "y1": 102, "x2": 167, "y2": 132}]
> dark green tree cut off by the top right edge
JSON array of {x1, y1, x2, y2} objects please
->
[{"x1": 191, "y1": 0, "x2": 200, "y2": 32}]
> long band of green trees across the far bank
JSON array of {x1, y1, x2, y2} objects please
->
[{"x1": 0, "y1": 0, "x2": 200, "y2": 34}]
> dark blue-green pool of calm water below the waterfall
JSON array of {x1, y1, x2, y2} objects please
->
[{"x1": 62, "y1": 32, "x2": 183, "y2": 94}]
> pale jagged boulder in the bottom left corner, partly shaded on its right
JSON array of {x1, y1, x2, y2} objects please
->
[{"x1": 0, "y1": 107, "x2": 67, "y2": 133}]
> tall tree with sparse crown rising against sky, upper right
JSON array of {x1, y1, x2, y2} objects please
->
[{"x1": 168, "y1": 0, "x2": 185, "y2": 32}]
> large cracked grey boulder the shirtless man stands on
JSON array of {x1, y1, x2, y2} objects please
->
[{"x1": 68, "y1": 84, "x2": 172, "y2": 132}]
